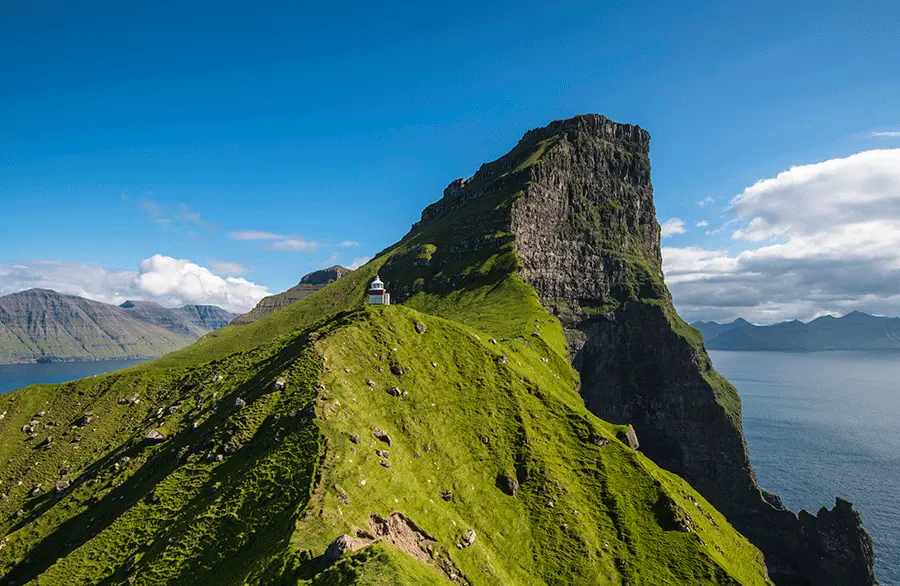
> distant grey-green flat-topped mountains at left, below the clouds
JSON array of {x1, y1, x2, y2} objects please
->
[{"x1": 0, "y1": 289, "x2": 235, "y2": 363}]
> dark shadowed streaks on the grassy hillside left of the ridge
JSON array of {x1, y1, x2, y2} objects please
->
[{"x1": 0, "y1": 313, "x2": 346, "y2": 584}]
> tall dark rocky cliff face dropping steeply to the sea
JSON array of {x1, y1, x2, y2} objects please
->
[{"x1": 414, "y1": 115, "x2": 876, "y2": 586}]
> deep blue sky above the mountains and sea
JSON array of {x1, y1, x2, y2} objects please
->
[{"x1": 0, "y1": 0, "x2": 900, "y2": 321}]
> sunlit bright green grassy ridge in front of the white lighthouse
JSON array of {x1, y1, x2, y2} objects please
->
[{"x1": 294, "y1": 307, "x2": 766, "y2": 584}]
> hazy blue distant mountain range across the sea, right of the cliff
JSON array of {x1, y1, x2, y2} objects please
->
[{"x1": 691, "y1": 311, "x2": 900, "y2": 352}]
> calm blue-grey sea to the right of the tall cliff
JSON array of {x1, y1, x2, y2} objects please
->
[{"x1": 709, "y1": 351, "x2": 900, "y2": 586}]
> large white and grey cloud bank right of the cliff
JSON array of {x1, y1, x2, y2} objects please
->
[{"x1": 663, "y1": 149, "x2": 900, "y2": 323}]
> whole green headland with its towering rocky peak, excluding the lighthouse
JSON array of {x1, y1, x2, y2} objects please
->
[{"x1": 0, "y1": 115, "x2": 874, "y2": 586}]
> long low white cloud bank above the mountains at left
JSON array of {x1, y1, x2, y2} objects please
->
[{"x1": 0, "y1": 254, "x2": 269, "y2": 313}]
